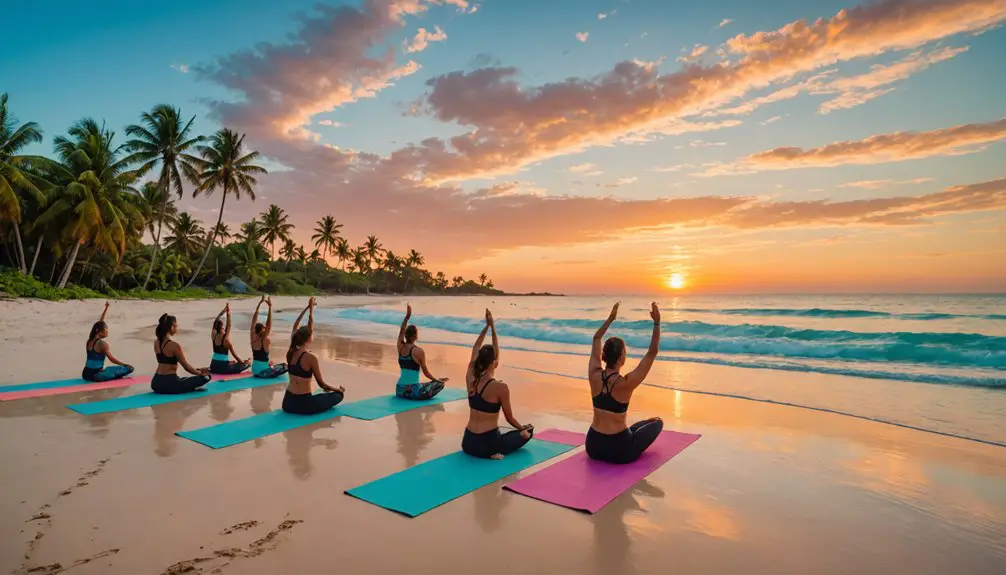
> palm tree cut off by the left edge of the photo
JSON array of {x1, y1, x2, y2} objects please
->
[{"x1": 0, "y1": 93, "x2": 51, "y2": 273}]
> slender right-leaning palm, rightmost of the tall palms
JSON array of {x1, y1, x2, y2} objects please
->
[{"x1": 185, "y1": 128, "x2": 269, "y2": 288}]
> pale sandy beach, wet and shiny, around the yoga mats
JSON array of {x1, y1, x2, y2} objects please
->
[{"x1": 0, "y1": 298, "x2": 1006, "y2": 575}]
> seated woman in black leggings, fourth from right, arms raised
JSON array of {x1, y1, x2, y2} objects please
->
[{"x1": 283, "y1": 298, "x2": 346, "y2": 415}]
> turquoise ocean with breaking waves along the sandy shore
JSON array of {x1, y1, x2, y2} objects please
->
[{"x1": 301, "y1": 296, "x2": 1006, "y2": 446}]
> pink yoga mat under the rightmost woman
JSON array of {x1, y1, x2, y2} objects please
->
[{"x1": 503, "y1": 431, "x2": 701, "y2": 513}]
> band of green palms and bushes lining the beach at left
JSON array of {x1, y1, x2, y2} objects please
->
[{"x1": 0, "y1": 94, "x2": 501, "y2": 300}]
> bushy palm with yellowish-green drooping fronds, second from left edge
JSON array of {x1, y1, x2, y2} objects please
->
[{"x1": 36, "y1": 118, "x2": 143, "y2": 288}]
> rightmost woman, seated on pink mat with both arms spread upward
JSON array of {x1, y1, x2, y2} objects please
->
[{"x1": 586, "y1": 303, "x2": 664, "y2": 463}]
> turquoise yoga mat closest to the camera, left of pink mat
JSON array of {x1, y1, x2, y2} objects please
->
[{"x1": 346, "y1": 439, "x2": 575, "y2": 517}]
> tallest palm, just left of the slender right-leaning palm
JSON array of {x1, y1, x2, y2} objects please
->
[{"x1": 126, "y1": 104, "x2": 203, "y2": 290}]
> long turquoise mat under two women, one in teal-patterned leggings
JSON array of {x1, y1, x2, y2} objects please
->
[{"x1": 177, "y1": 388, "x2": 468, "y2": 449}]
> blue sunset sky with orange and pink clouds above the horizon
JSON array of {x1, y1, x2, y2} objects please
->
[{"x1": 0, "y1": 0, "x2": 1006, "y2": 295}]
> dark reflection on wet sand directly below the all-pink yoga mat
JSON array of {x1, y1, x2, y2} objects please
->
[{"x1": 591, "y1": 480, "x2": 664, "y2": 575}]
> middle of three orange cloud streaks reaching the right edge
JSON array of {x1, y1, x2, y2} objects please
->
[{"x1": 696, "y1": 118, "x2": 1006, "y2": 176}]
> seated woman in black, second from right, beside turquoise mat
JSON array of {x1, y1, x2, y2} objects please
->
[{"x1": 461, "y1": 310, "x2": 534, "y2": 459}]
